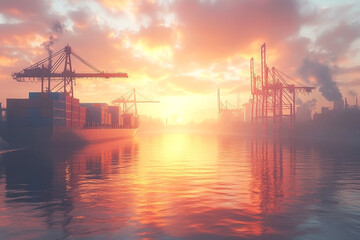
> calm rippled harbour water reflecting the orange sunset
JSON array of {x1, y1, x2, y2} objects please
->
[{"x1": 0, "y1": 133, "x2": 360, "y2": 240}]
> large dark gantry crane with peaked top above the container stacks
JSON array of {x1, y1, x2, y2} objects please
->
[{"x1": 12, "y1": 45, "x2": 128, "y2": 97}]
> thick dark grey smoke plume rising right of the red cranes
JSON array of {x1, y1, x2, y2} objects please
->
[{"x1": 298, "y1": 58, "x2": 343, "y2": 103}]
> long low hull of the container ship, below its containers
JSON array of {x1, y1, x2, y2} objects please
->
[{"x1": 1, "y1": 127, "x2": 137, "y2": 146}]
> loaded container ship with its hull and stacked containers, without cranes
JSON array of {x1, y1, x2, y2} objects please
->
[{"x1": 0, "y1": 92, "x2": 139, "y2": 145}]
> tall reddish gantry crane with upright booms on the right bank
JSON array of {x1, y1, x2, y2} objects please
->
[{"x1": 250, "y1": 43, "x2": 315, "y2": 131}]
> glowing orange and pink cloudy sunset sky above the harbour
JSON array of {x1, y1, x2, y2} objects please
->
[{"x1": 0, "y1": 0, "x2": 360, "y2": 123}]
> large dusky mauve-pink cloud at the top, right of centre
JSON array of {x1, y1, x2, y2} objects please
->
[{"x1": 171, "y1": 0, "x2": 304, "y2": 62}]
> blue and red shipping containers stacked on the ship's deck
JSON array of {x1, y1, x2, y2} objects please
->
[{"x1": 6, "y1": 92, "x2": 139, "y2": 128}]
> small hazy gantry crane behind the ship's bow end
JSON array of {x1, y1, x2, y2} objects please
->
[{"x1": 112, "y1": 88, "x2": 159, "y2": 116}]
